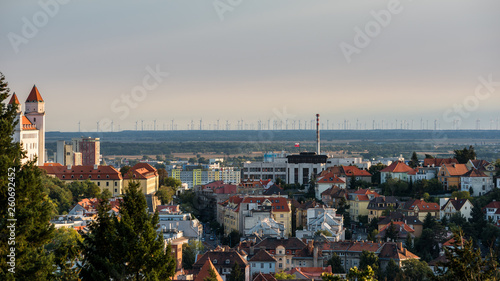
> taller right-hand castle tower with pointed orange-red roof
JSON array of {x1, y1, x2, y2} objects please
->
[{"x1": 24, "y1": 85, "x2": 45, "y2": 166}]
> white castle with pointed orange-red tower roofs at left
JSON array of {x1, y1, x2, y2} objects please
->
[{"x1": 9, "y1": 86, "x2": 45, "y2": 166}]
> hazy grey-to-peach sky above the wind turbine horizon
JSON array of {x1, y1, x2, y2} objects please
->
[{"x1": 0, "y1": 0, "x2": 500, "y2": 131}]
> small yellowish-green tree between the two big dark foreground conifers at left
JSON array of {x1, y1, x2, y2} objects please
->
[{"x1": 45, "y1": 228, "x2": 83, "y2": 281}]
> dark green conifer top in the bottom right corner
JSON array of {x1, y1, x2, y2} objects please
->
[{"x1": 436, "y1": 230, "x2": 500, "y2": 281}]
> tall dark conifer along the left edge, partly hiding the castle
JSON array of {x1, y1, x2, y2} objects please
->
[{"x1": 0, "y1": 73, "x2": 54, "y2": 280}]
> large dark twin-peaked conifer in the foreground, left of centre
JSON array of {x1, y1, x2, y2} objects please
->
[{"x1": 81, "y1": 182, "x2": 176, "y2": 280}]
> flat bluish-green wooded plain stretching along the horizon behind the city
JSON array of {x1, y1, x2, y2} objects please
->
[{"x1": 46, "y1": 130, "x2": 500, "y2": 161}]
